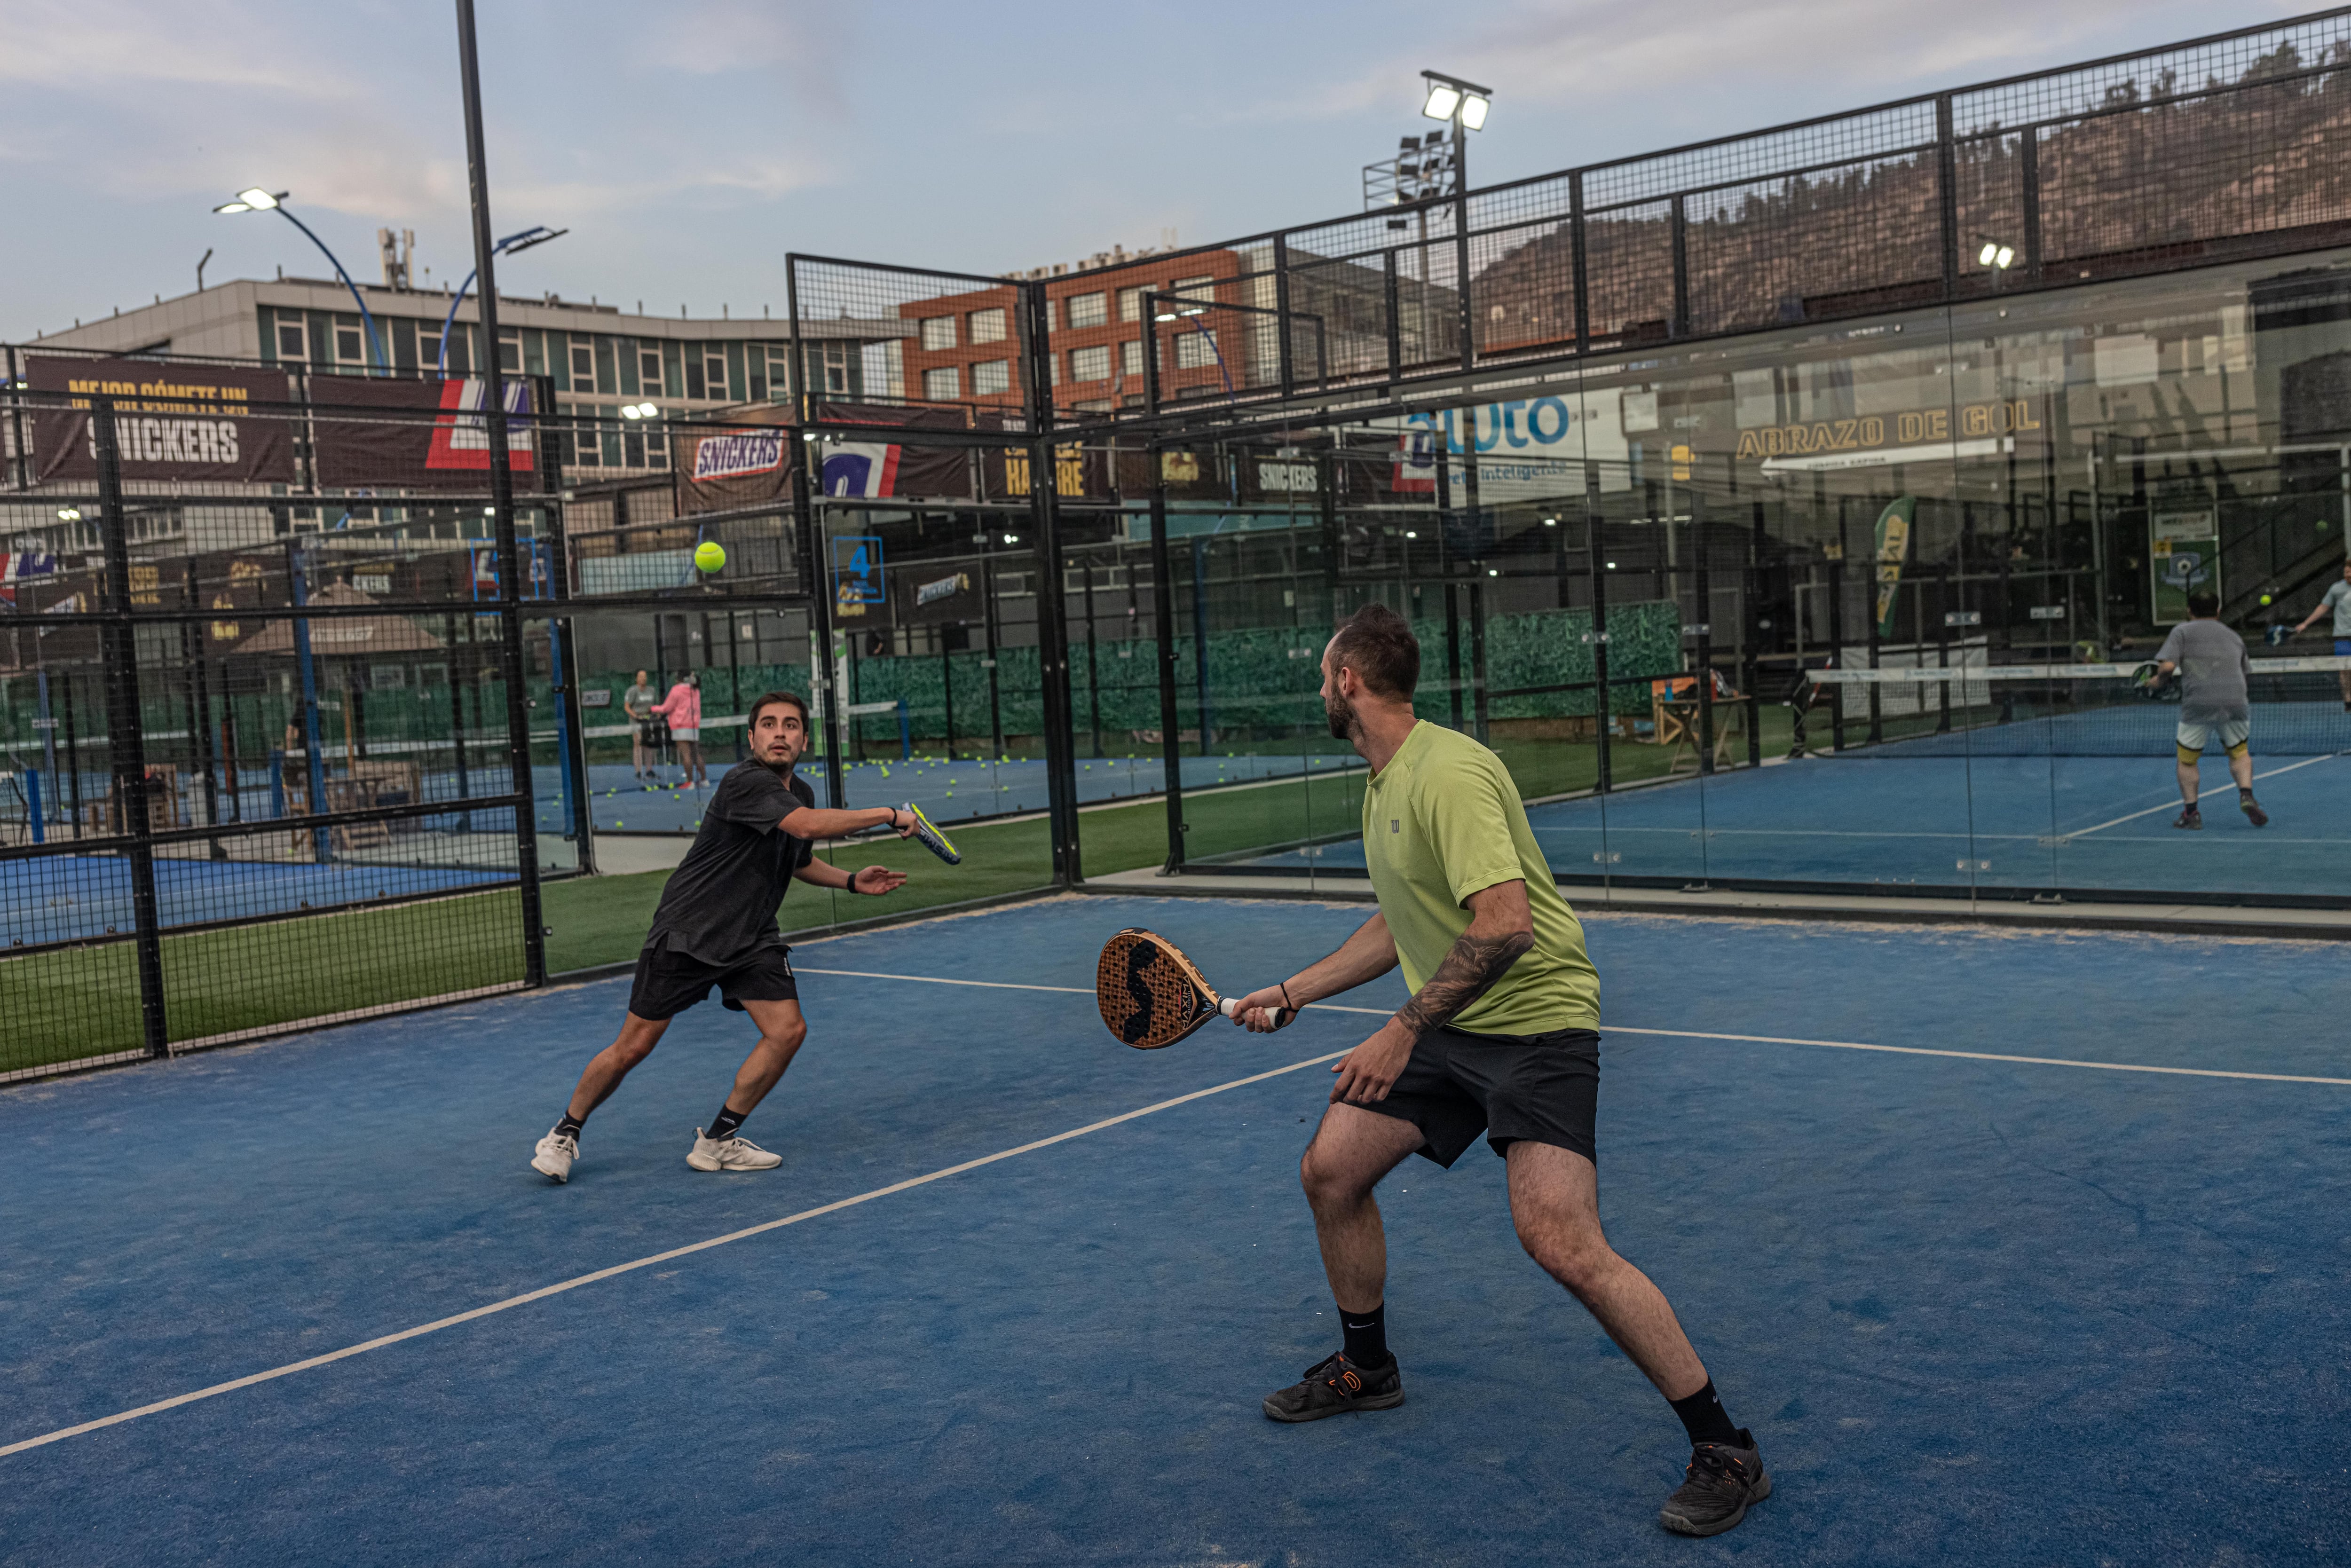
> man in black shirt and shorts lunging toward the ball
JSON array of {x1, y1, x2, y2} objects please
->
[{"x1": 531, "y1": 691, "x2": 915, "y2": 1182}]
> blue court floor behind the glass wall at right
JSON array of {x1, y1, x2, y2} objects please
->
[{"x1": 1246, "y1": 748, "x2": 2351, "y2": 898}]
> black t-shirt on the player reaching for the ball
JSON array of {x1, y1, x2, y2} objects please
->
[{"x1": 644, "y1": 762, "x2": 816, "y2": 964}]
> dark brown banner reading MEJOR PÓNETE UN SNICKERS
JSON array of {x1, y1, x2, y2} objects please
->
[{"x1": 26, "y1": 355, "x2": 294, "y2": 484}]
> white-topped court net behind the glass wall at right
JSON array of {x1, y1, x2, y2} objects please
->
[{"x1": 1796, "y1": 658, "x2": 2351, "y2": 757}]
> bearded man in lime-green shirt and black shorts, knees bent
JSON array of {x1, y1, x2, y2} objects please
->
[{"x1": 1234, "y1": 604, "x2": 1770, "y2": 1535}]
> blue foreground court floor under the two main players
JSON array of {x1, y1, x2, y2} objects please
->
[{"x1": 0, "y1": 898, "x2": 2351, "y2": 1568}]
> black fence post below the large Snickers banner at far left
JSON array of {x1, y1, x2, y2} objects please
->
[{"x1": 89, "y1": 397, "x2": 172, "y2": 1056}]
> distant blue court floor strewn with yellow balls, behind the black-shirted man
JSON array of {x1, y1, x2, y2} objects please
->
[{"x1": 567, "y1": 752, "x2": 1364, "y2": 832}]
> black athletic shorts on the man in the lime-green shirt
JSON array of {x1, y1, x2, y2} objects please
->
[{"x1": 1364, "y1": 1030, "x2": 1601, "y2": 1166}]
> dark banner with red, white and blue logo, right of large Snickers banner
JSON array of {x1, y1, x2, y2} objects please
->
[{"x1": 310, "y1": 376, "x2": 538, "y2": 494}]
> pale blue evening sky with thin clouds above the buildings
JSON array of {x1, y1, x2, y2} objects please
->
[{"x1": 0, "y1": 0, "x2": 2311, "y2": 341}]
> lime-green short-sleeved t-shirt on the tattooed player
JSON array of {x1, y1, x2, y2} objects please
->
[{"x1": 1364, "y1": 722, "x2": 1601, "y2": 1034}]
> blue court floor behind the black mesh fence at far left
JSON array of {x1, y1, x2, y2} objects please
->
[{"x1": 0, "y1": 851, "x2": 515, "y2": 947}]
